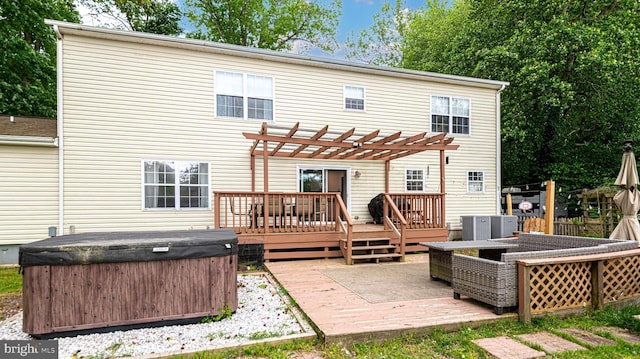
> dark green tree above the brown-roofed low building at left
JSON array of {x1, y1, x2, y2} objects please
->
[{"x1": 0, "y1": 0, "x2": 79, "y2": 117}]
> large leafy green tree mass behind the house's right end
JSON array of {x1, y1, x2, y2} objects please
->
[{"x1": 404, "y1": 0, "x2": 640, "y2": 188}]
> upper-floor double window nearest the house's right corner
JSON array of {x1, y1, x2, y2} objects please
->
[{"x1": 431, "y1": 96, "x2": 471, "y2": 135}]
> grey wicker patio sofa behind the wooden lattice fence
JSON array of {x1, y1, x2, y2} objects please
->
[{"x1": 451, "y1": 233, "x2": 638, "y2": 314}]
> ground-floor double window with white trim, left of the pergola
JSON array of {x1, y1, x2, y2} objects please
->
[{"x1": 142, "y1": 161, "x2": 211, "y2": 209}]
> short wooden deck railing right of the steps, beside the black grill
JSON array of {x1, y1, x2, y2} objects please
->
[{"x1": 389, "y1": 193, "x2": 445, "y2": 229}]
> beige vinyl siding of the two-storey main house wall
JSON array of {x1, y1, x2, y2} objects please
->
[{"x1": 58, "y1": 34, "x2": 497, "y2": 232}]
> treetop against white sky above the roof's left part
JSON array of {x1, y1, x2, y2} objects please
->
[{"x1": 79, "y1": 0, "x2": 182, "y2": 35}]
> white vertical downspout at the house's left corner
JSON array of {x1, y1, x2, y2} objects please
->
[{"x1": 53, "y1": 25, "x2": 64, "y2": 235}]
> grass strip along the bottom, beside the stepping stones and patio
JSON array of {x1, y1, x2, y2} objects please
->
[{"x1": 175, "y1": 306, "x2": 640, "y2": 359}]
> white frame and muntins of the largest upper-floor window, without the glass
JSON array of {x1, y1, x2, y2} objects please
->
[{"x1": 213, "y1": 70, "x2": 276, "y2": 122}]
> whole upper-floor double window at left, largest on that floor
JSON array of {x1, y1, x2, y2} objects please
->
[{"x1": 215, "y1": 71, "x2": 273, "y2": 121}]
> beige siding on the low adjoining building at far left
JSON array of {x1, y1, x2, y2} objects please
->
[{"x1": 0, "y1": 145, "x2": 58, "y2": 245}]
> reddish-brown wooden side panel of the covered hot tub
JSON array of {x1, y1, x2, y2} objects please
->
[{"x1": 23, "y1": 255, "x2": 238, "y2": 334}]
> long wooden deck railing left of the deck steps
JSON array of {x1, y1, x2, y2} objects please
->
[{"x1": 214, "y1": 192, "x2": 348, "y2": 234}]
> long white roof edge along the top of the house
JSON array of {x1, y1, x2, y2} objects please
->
[{"x1": 45, "y1": 19, "x2": 509, "y2": 91}]
